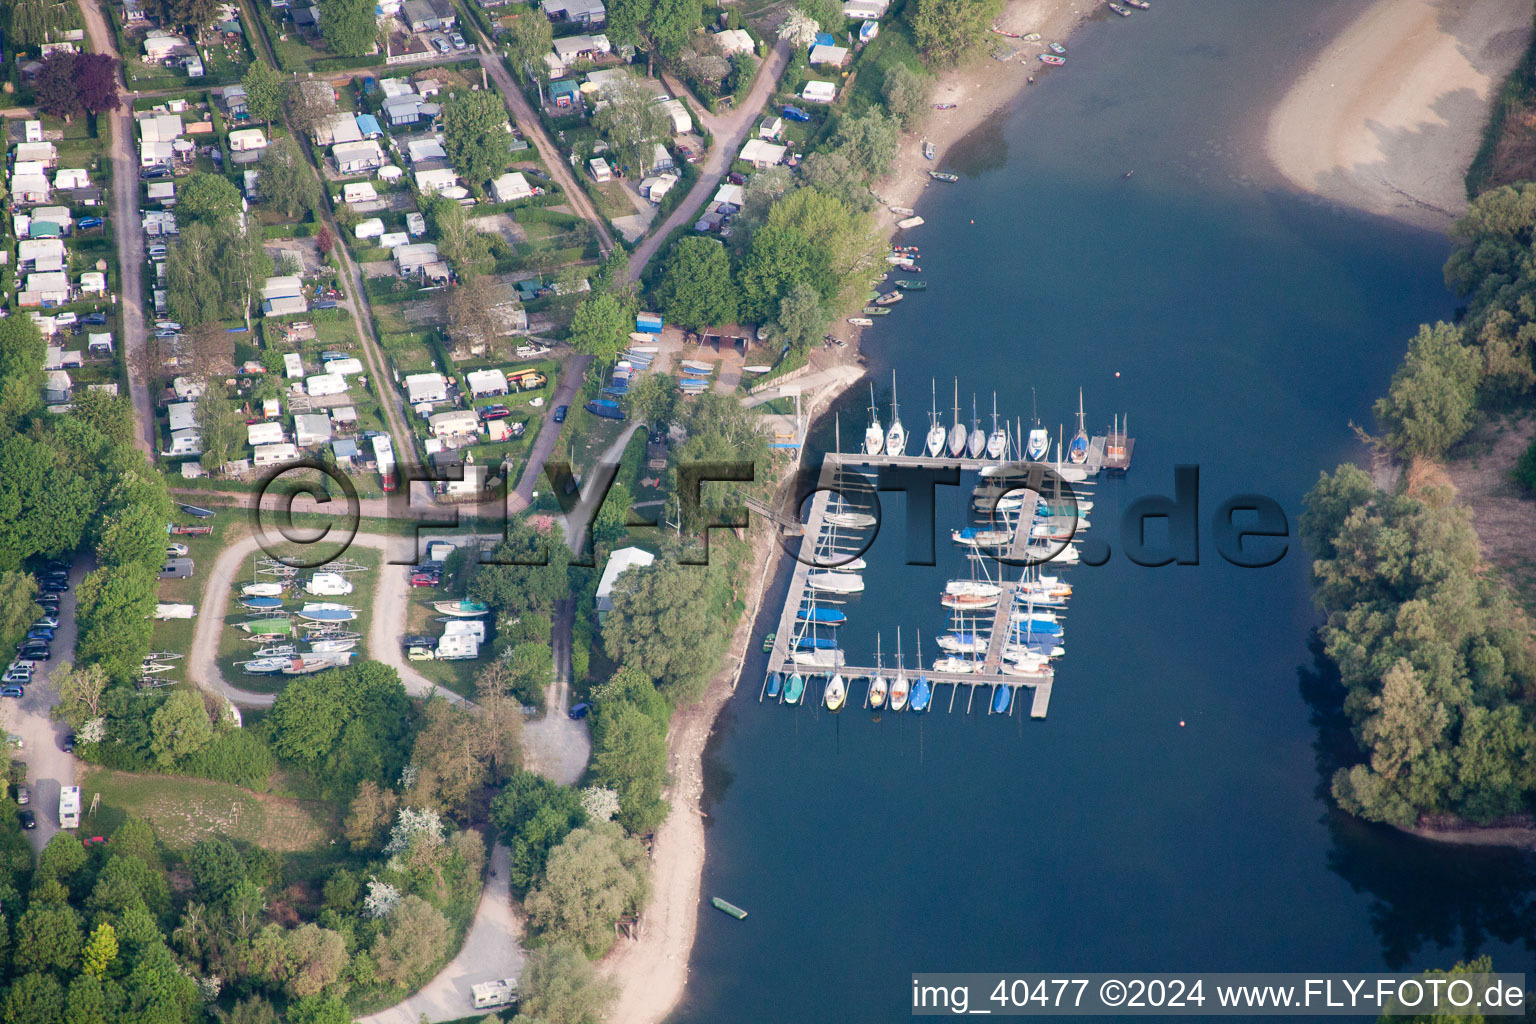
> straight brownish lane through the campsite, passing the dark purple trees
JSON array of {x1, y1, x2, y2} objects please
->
[{"x1": 80, "y1": 0, "x2": 157, "y2": 456}]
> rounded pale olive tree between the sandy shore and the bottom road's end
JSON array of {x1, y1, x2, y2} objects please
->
[{"x1": 524, "y1": 821, "x2": 647, "y2": 958}]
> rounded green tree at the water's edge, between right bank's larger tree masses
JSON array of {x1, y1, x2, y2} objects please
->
[{"x1": 1376, "y1": 322, "x2": 1481, "y2": 459}]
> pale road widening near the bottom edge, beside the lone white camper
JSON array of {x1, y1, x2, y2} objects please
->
[{"x1": 358, "y1": 846, "x2": 522, "y2": 1024}]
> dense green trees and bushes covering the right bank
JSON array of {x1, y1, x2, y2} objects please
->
[{"x1": 1301, "y1": 183, "x2": 1536, "y2": 826}]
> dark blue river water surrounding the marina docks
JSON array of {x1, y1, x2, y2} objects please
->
[{"x1": 679, "y1": 0, "x2": 1533, "y2": 1022}]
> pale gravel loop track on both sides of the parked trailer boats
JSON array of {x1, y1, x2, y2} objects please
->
[{"x1": 187, "y1": 533, "x2": 467, "y2": 708}]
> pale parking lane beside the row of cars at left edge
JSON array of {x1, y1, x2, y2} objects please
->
[{"x1": 6, "y1": 557, "x2": 95, "y2": 849}]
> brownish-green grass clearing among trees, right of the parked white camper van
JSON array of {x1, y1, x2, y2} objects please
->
[{"x1": 80, "y1": 766, "x2": 338, "y2": 852}]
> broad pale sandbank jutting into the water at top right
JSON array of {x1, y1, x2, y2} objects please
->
[{"x1": 1266, "y1": 0, "x2": 1531, "y2": 230}]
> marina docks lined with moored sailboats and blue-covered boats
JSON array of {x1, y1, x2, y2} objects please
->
[{"x1": 759, "y1": 381, "x2": 1135, "y2": 718}]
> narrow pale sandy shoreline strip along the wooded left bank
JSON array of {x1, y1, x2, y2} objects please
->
[{"x1": 602, "y1": 0, "x2": 1097, "y2": 1024}]
